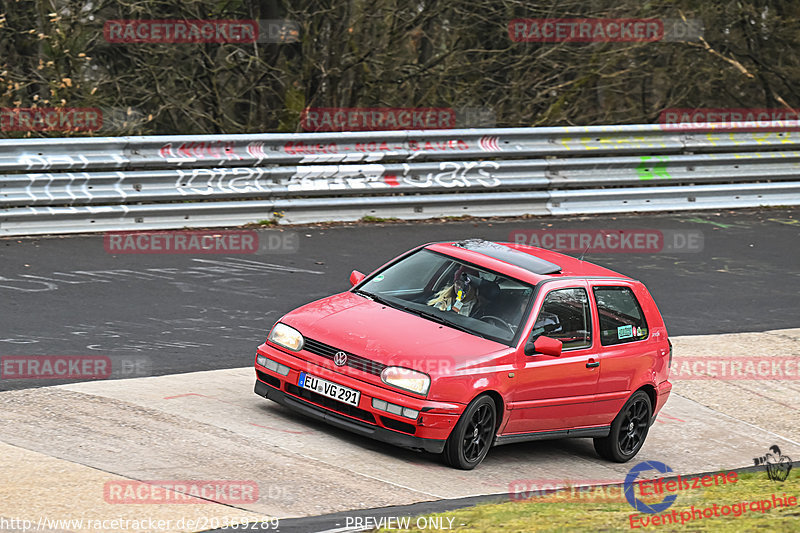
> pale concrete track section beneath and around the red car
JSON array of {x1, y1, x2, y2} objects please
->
[{"x1": 0, "y1": 329, "x2": 800, "y2": 531}]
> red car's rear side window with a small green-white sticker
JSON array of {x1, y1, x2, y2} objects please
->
[{"x1": 593, "y1": 287, "x2": 648, "y2": 346}]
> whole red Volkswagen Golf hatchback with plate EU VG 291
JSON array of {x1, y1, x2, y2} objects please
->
[{"x1": 255, "y1": 240, "x2": 672, "y2": 469}]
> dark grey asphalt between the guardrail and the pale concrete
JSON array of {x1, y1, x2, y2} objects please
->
[{"x1": 0, "y1": 208, "x2": 800, "y2": 390}]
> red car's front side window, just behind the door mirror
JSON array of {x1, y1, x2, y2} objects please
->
[{"x1": 533, "y1": 289, "x2": 592, "y2": 350}]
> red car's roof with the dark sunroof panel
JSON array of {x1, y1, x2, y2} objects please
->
[{"x1": 425, "y1": 239, "x2": 631, "y2": 285}]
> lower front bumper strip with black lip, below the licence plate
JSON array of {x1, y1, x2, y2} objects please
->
[{"x1": 255, "y1": 378, "x2": 446, "y2": 453}]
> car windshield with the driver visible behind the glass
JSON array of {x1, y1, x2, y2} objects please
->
[{"x1": 355, "y1": 250, "x2": 533, "y2": 345}]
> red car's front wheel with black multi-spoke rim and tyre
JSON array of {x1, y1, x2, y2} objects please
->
[{"x1": 442, "y1": 395, "x2": 497, "y2": 470}]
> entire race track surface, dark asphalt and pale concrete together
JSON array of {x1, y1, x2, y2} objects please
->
[{"x1": 0, "y1": 209, "x2": 800, "y2": 531}]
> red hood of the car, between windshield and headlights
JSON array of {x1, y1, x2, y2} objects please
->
[{"x1": 281, "y1": 292, "x2": 510, "y2": 373}]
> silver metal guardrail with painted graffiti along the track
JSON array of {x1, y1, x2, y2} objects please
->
[{"x1": 0, "y1": 124, "x2": 800, "y2": 235}]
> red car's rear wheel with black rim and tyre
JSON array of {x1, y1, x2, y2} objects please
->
[{"x1": 594, "y1": 390, "x2": 653, "y2": 463}]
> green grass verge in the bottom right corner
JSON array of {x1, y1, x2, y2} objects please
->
[{"x1": 379, "y1": 471, "x2": 800, "y2": 533}]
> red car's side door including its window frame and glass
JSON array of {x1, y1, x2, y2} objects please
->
[{"x1": 503, "y1": 280, "x2": 598, "y2": 434}]
